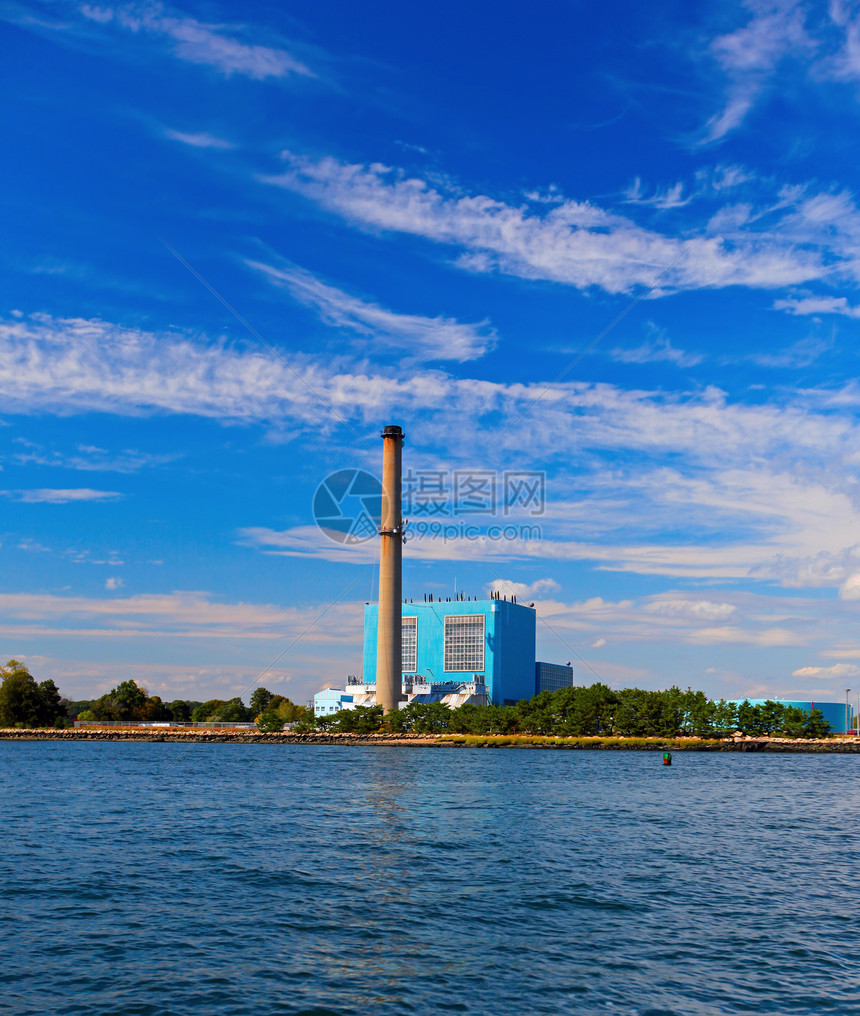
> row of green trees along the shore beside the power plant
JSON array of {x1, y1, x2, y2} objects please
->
[{"x1": 0, "y1": 659, "x2": 831, "y2": 738}]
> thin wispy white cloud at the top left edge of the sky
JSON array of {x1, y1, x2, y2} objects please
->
[{"x1": 80, "y1": 3, "x2": 314, "y2": 81}]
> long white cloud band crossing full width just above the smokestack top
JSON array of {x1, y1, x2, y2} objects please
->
[{"x1": 6, "y1": 314, "x2": 860, "y2": 469}]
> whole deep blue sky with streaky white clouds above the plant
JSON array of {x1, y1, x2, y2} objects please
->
[{"x1": 0, "y1": 2, "x2": 860, "y2": 701}]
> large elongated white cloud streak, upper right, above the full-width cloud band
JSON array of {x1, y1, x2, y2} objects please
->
[{"x1": 261, "y1": 151, "x2": 833, "y2": 294}]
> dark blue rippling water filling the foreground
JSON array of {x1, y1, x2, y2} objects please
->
[{"x1": 0, "y1": 742, "x2": 860, "y2": 1016}]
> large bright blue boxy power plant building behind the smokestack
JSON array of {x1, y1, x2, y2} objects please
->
[{"x1": 364, "y1": 598, "x2": 536, "y2": 705}]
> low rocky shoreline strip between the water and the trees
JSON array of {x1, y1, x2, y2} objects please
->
[{"x1": 0, "y1": 726, "x2": 860, "y2": 755}]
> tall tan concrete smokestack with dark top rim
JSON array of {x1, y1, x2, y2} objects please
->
[{"x1": 376, "y1": 426, "x2": 404, "y2": 712}]
